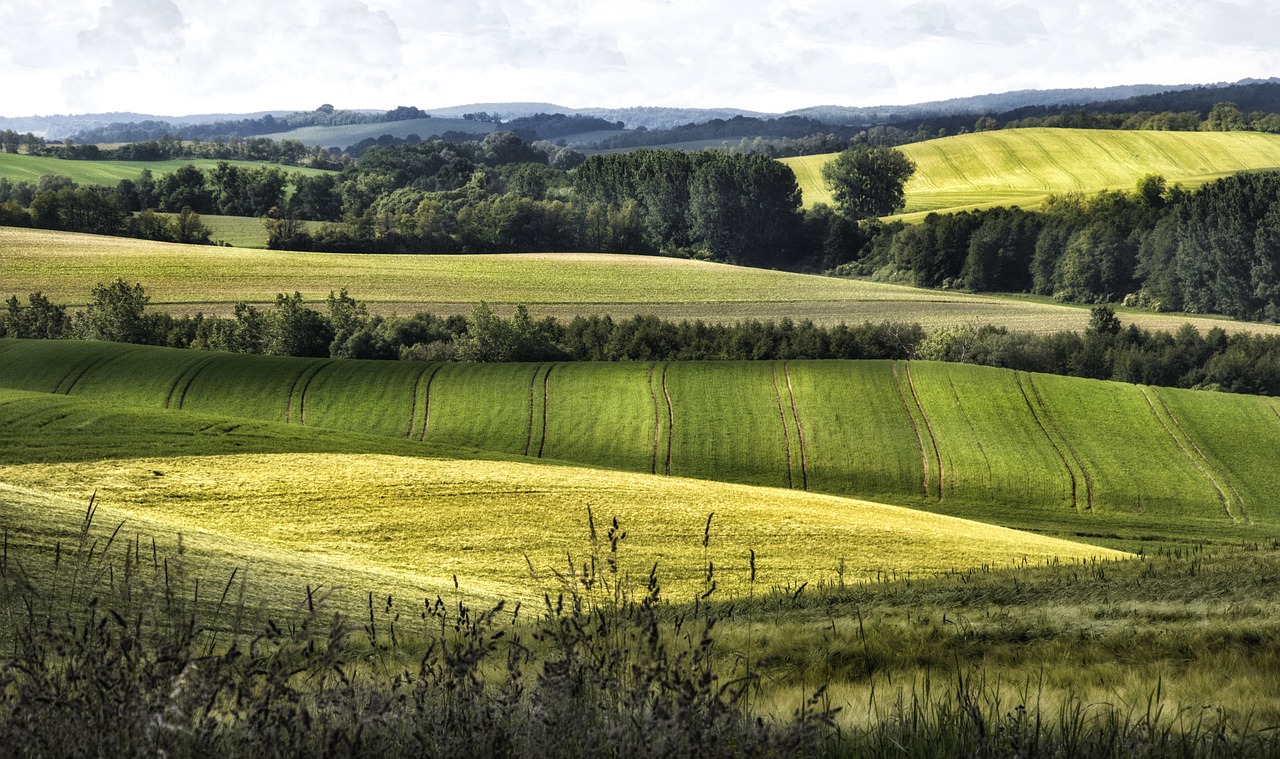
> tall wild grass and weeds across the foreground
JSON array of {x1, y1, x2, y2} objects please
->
[{"x1": 0, "y1": 496, "x2": 1280, "y2": 756}]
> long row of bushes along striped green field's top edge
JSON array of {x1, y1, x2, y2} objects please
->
[{"x1": 0, "y1": 278, "x2": 1280, "y2": 395}]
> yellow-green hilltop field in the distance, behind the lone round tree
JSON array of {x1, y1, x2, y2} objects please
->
[{"x1": 783, "y1": 128, "x2": 1280, "y2": 218}]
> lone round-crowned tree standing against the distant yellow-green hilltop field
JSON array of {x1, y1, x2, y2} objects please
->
[{"x1": 822, "y1": 145, "x2": 915, "y2": 219}]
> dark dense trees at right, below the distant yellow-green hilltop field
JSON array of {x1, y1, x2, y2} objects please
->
[{"x1": 835, "y1": 172, "x2": 1280, "y2": 321}]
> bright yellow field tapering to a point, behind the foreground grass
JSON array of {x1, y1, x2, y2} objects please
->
[{"x1": 0, "y1": 454, "x2": 1125, "y2": 602}]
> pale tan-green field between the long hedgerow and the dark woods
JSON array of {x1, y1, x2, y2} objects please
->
[{"x1": 10, "y1": 221, "x2": 1280, "y2": 334}]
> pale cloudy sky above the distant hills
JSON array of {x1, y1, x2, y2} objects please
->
[{"x1": 0, "y1": 0, "x2": 1280, "y2": 116}]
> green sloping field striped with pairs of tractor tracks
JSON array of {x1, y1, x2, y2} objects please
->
[{"x1": 0, "y1": 340, "x2": 1280, "y2": 540}]
